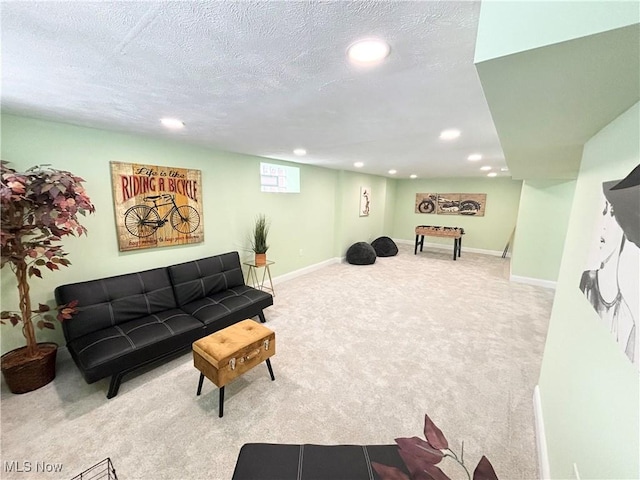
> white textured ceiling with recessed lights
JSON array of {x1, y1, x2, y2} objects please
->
[{"x1": 1, "y1": 1, "x2": 508, "y2": 178}]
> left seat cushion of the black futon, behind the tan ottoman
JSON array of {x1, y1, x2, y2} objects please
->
[{"x1": 67, "y1": 309, "x2": 204, "y2": 383}]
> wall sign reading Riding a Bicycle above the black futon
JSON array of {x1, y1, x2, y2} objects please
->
[{"x1": 111, "y1": 162, "x2": 204, "y2": 251}]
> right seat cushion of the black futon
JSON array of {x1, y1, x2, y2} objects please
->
[{"x1": 181, "y1": 285, "x2": 273, "y2": 325}]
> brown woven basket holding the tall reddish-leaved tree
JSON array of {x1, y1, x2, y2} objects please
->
[{"x1": 0, "y1": 343, "x2": 58, "y2": 393}]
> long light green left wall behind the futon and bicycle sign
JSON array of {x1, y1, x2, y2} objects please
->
[{"x1": 0, "y1": 115, "x2": 393, "y2": 352}]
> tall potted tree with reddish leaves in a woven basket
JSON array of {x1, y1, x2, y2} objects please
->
[{"x1": 0, "y1": 161, "x2": 95, "y2": 393}]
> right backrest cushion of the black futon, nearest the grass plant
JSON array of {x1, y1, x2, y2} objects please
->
[{"x1": 168, "y1": 252, "x2": 244, "y2": 305}]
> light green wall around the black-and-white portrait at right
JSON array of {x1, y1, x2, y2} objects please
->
[{"x1": 539, "y1": 104, "x2": 640, "y2": 479}]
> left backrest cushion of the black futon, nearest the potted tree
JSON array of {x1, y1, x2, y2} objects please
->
[{"x1": 55, "y1": 268, "x2": 177, "y2": 342}]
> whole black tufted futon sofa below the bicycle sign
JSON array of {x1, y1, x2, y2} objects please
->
[{"x1": 55, "y1": 252, "x2": 273, "y2": 398}]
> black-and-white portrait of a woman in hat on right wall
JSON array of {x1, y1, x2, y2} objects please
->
[{"x1": 580, "y1": 165, "x2": 640, "y2": 369}]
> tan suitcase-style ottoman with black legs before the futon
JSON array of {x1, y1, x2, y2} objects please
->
[{"x1": 193, "y1": 320, "x2": 276, "y2": 417}]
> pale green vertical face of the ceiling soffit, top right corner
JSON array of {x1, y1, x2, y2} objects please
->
[{"x1": 474, "y1": 0, "x2": 640, "y2": 63}]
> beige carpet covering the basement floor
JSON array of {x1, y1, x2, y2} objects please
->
[{"x1": 0, "y1": 245, "x2": 553, "y2": 480}]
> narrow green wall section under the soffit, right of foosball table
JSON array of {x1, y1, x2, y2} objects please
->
[{"x1": 511, "y1": 180, "x2": 576, "y2": 282}]
